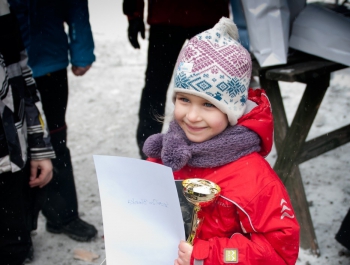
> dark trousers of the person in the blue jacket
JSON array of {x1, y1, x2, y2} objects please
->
[{"x1": 35, "y1": 69, "x2": 78, "y2": 225}]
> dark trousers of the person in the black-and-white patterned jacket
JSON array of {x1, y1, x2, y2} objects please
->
[{"x1": 0, "y1": 165, "x2": 45, "y2": 265}]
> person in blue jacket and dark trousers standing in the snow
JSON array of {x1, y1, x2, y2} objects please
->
[{"x1": 9, "y1": 0, "x2": 97, "y2": 241}]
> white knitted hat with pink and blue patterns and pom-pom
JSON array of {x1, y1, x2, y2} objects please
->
[{"x1": 173, "y1": 17, "x2": 252, "y2": 125}]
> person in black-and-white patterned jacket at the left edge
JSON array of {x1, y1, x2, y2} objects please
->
[{"x1": 0, "y1": 0, "x2": 55, "y2": 265}]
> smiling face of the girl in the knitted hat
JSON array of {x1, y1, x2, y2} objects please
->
[{"x1": 174, "y1": 93, "x2": 228, "y2": 143}]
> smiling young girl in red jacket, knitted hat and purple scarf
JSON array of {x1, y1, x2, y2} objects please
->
[{"x1": 143, "y1": 18, "x2": 299, "y2": 265}]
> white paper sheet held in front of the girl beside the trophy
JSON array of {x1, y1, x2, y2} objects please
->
[{"x1": 94, "y1": 155, "x2": 185, "y2": 265}]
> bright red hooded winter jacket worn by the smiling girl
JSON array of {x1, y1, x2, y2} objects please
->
[{"x1": 149, "y1": 90, "x2": 299, "y2": 265}]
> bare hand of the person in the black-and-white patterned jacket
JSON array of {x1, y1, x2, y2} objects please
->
[{"x1": 29, "y1": 159, "x2": 52, "y2": 188}]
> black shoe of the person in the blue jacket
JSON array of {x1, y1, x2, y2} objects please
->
[{"x1": 46, "y1": 217, "x2": 97, "y2": 242}]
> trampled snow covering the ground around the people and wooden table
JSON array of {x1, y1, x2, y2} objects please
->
[{"x1": 28, "y1": 0, "x2": 350, "y2": 265}]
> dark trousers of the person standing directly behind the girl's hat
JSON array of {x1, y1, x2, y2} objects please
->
[{"x1": 136, "y1": 25, "x2": 210, "y2": 158}]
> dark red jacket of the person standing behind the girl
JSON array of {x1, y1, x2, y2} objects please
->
[{"x1": 123, "y1": 0, "x2": 229, "y2": 27}]
